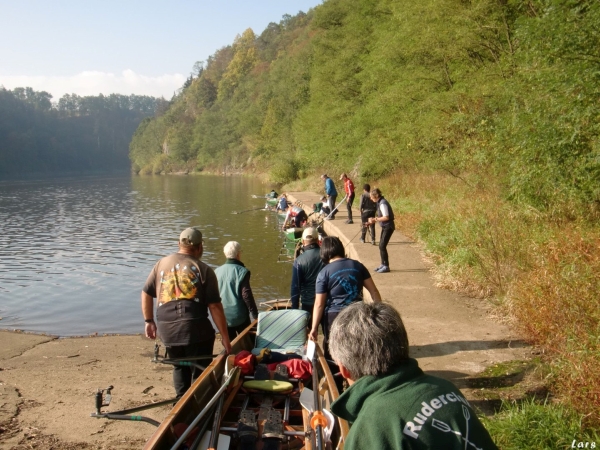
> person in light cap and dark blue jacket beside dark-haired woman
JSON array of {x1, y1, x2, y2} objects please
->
[{"x1": 291, "y1": 227, "x2": 324, "y2": 323}]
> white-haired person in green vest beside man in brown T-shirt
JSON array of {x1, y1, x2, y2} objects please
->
[{"x1": 215, "y1": 241, "x2": 258, "y2": 340}]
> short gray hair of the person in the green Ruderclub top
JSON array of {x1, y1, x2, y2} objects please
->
[{"x1": 329, "y1": 302, "x2": 409, "y2": 380}]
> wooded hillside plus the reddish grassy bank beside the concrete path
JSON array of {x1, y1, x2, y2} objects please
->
[{"x1": 130, "y1": 0, "x2": 600, "y2": 442}]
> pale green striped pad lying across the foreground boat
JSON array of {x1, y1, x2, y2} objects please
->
[{"x1": 253, "y1": 309, "x2": 308, "y2": 354}]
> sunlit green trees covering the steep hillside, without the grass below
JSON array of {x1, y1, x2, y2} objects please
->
[{"x1": 130, "y1": 0, "x2": 600, "y2": 220}]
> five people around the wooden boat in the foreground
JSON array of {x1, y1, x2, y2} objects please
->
[{"x1": 142, "y1": 221, "x2": 497, "y2": 450}]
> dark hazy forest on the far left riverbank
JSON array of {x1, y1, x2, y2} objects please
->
[{"x1": 0, "y1": 87, "x2": 161, "y2": 179}]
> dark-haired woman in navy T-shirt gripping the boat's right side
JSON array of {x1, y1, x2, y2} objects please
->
[{"x1": 309, "y1": 236, "x2": 381, "y2": 357}]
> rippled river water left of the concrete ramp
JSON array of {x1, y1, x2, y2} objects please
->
[{"x1": 0, "y1": 176, "x2": 291, "y2": 336}]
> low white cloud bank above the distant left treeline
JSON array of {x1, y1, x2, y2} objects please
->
[{"x1": 0, "y1": 69, "x2": 186, "y2": 101}]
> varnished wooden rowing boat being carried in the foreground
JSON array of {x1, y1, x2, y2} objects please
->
[{"x1": 144, "y1": 310, "x2": 349, "y2": 450}]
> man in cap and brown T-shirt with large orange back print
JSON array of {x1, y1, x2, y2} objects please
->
[{"x1": 142, "y1": 228, "x2": 231, "y2": 397}]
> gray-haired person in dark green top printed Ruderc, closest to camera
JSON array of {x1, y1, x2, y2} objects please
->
[{"x1": 329, "y1": 302, "x2": 497, "y2": 450}]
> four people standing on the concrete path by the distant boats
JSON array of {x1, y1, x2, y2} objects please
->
[{"x1": 322, "y1": 173, "x2": 396, "y2": 273}]
